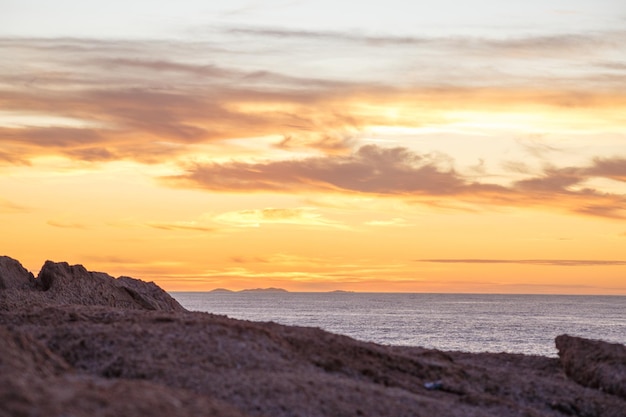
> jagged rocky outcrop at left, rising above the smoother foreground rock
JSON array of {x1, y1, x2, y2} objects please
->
[{"x1": 0, "y1": 257, "x2": 185, "y2": 311}]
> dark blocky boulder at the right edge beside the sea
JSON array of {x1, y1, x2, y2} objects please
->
[{"x1": 556, "y1": 335, "x2": 626, "y2": 400}]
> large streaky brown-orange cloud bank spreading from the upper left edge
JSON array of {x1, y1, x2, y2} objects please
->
[{"x1": 0, "y1": 39, "x2": 368, "y2": 163}]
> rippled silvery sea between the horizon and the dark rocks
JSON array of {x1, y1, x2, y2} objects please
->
[{"x1": 172, "y1": 292, "x2": 626, "y2": 356}]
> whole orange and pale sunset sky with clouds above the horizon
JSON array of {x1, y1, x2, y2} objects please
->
[{"x1": 0, "y1": 0, "x2": 626, "y2": 295}]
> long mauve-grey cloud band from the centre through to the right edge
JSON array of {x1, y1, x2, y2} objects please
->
[{"x1": 163, "y1": 145, "x2": 626, "y2": 219}]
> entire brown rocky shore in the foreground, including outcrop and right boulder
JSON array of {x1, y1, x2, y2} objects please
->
[{"x1": 0, "y1": 257, "x2": 626, "y2": 417}]
